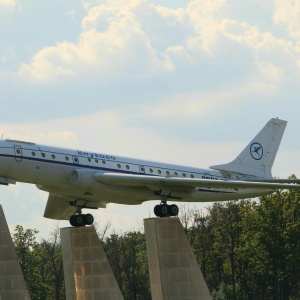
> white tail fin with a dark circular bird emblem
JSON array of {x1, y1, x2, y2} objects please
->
[{"x1": 210, "y1": 118, "x2": 287, "y2": 179}]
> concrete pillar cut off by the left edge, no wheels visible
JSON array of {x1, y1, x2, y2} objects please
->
[{"x1": 0, "y1": 205, "x2": 30, "y2": 300}]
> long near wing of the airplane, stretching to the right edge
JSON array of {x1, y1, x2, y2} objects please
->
[{"x1": 94, "y1": 173, "x2": 300, "y2": 190}]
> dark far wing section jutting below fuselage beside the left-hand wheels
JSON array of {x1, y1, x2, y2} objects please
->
[{"x1": 44, "y1": 193, "x2": 75, "y2": 220}]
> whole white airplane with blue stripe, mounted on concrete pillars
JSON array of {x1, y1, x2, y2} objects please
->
[{"x1": 0, "y1": 118, "x2": 300, "y2": 226}]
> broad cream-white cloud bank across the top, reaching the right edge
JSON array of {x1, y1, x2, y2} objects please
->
[{"x1": 18, "y1": 0, "x2": 300, "y2": 86}]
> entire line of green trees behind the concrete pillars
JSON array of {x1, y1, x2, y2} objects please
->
[{"x1": 13, "y1": 185, "x2": 300, "y2": 300}]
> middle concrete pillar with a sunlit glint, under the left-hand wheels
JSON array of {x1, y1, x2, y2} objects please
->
[{"x1": 60, "y1": 227, "x2": 124, "y2": 300}]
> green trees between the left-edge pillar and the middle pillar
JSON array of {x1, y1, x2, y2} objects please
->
[{"x1": 13, "y1": 225, "x2": 65, "y2": 300}]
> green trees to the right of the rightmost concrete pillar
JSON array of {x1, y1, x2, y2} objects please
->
[{"x1": 188, "y1": 190, "x2": 300, "y2": 300}]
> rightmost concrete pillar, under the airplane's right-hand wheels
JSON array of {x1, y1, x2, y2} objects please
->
[{"x1": 144, "y1": 218, "x2": 212, "y2": 300}]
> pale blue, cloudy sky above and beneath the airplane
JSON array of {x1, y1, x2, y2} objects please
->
[{"x1": 0, "y1": 0, "x2": 300, "y2": 237}]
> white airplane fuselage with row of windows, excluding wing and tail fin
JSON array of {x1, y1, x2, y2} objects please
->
[{"x1": 0, "y1": 140, "x2": 272, "y2": 207}]
